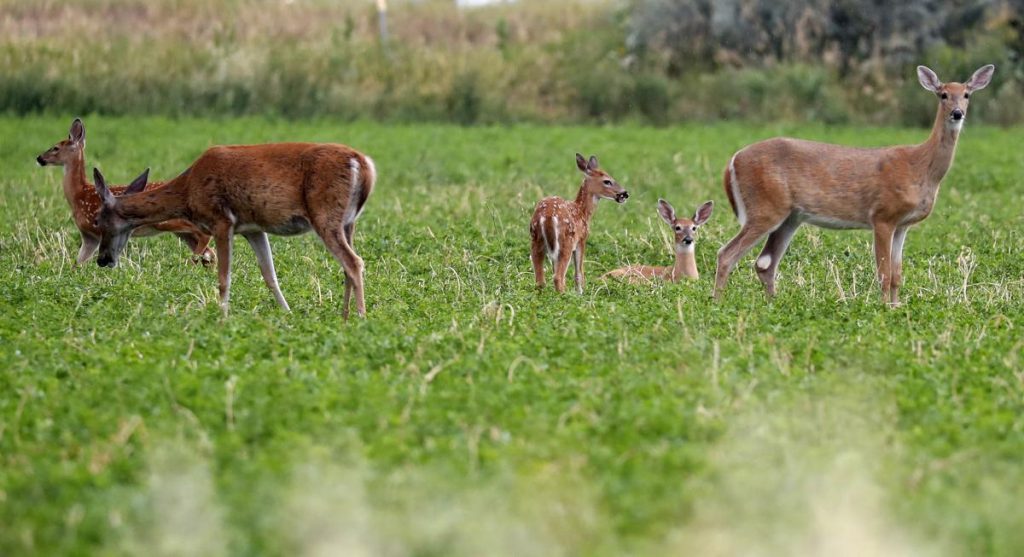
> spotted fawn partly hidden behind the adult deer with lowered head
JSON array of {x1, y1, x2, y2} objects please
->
[{"x1": 36, "y1": 118, "x2": 213, "y2": 265}]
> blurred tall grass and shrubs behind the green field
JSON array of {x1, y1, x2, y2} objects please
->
[{"x1": 0, "y1": 0, "x2": 1024, "y2": 125}]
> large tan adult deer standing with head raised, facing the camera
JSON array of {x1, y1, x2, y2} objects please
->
[{"x1": 715, "y1": 65, "x2": 995, "y2": 305}]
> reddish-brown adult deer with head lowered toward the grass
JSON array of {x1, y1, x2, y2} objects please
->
[{"x1": 95, "y1": 143, "x2": 377, "y2": 319}]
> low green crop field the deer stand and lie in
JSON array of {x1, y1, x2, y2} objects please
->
[{"x1": 0, "y1": 117, "x2": 1024, "y2": 556}]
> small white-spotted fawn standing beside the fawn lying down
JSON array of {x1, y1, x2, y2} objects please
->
[{"x1": 529, "y1": 153, "x2": 630, "y2": 294}]
